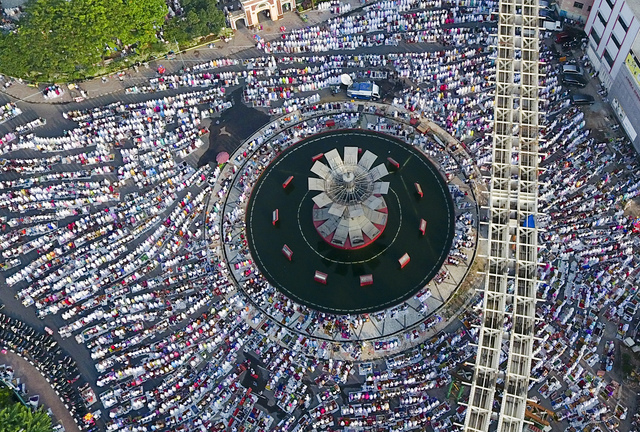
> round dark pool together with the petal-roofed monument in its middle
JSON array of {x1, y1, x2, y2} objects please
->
[{"x1": 246, "y1": 130, "x2": 455, "y2": 314}]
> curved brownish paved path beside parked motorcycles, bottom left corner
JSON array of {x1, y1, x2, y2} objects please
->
[{"x1": 0, "y1": 351, "x2": 80, "y2": 432}]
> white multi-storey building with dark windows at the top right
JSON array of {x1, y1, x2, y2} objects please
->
[{"x1": 585, "y1": 0, "x2": 640, "y2": 152}]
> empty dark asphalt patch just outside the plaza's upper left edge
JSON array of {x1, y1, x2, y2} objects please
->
[{"x1": 198, "y1": 88, "x2": 269, "y2": 167}]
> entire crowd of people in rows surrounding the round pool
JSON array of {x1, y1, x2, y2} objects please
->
[{"x1": 0, "y1": 0, "x2": 640, "y2": 431}]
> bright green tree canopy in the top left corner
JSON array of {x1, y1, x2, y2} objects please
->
[{"x1": 0, "y1": 0, "x2": 168, "y2": 81}]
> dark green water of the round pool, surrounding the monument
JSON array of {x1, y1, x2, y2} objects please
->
[{"x1": 247, "y1": 130, "x2": 454, "y2": 313}]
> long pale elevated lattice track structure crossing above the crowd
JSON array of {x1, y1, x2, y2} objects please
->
[{"x1": 464, "y1": 0, "x2": 540, "y2": 432}]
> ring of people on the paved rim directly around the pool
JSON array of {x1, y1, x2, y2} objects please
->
[{"x1": 222, "y1": 103, "x2": 475, "y2": 348}]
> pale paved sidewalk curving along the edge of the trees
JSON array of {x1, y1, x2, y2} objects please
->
[{"x1": 0, "y1": 0, "x2": 362, "y2": 104}]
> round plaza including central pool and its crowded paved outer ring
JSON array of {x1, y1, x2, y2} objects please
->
[{"x1": 211, "y1": 103, "x2": 478, "y2": 356}]
